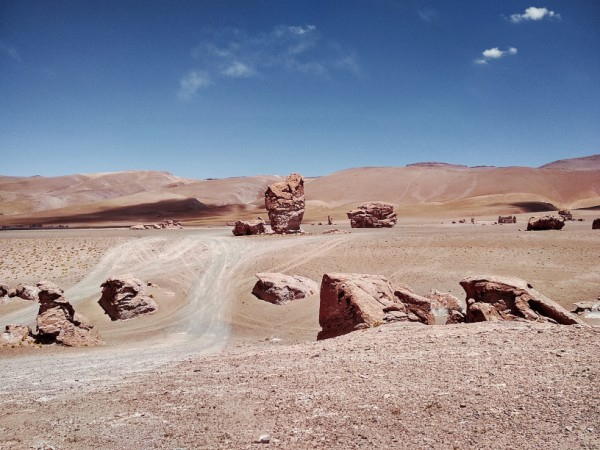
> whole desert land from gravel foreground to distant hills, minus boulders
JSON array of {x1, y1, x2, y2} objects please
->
[{"x1": 0, "y1": 158, "x2": 600, "y2": 449}]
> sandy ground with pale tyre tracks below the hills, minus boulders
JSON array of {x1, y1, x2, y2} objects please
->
[{"x1": 0, "y1": 222, "x2": 600, "y2": 449}]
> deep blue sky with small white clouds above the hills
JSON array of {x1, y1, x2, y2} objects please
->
[{"x1": 0, "y1": 0, "x2": 600, "y2": 178}]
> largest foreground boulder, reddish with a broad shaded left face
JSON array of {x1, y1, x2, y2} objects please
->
[{"x1": 317, "y1": 273, "x2": 433, "y2": 339}]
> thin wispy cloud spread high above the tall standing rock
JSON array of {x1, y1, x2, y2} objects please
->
[{"x1": 180, "y1": 25, "x2": 360, "y2": 99}]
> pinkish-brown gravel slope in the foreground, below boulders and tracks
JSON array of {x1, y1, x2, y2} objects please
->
[{"x1": 0, "y1": 323, "x2": 600, "y2": 449}]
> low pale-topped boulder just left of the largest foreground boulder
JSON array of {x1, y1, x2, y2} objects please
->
[{"x1": 252, "y1": 273, "x2": 319, "y2": 305}]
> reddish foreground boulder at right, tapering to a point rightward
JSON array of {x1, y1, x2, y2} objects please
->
[{"x1": 460, "y1": 276, "x2": 585, "y2": 325}]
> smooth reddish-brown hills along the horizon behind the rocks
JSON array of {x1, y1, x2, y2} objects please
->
[{"x1": 0, "y1": 155, "x2": 600, "y2": 225}]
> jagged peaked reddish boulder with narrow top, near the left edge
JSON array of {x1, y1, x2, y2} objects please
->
[{"x1": 36, "y1": 281, "x2": 103, "y2": 347}]
